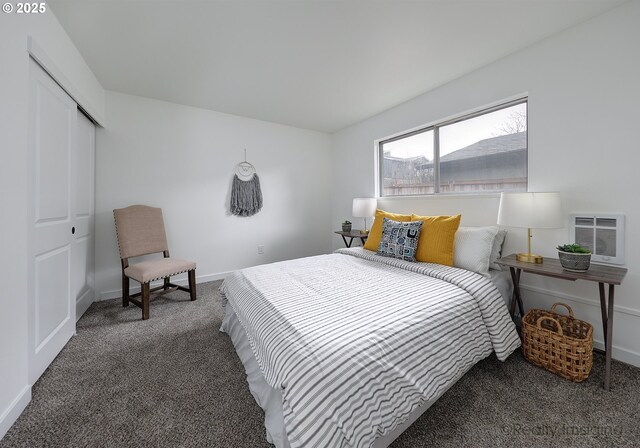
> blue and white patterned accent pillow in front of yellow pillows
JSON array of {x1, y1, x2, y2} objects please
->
[{"x1": 377, "y1": 218, "x2": 422, "y2": 261}]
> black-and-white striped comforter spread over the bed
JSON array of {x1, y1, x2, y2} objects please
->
[{"x1": 220, "y1": 248, "x2": 520, "y2": 448}]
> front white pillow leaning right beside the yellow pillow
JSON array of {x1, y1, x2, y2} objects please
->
[{"x1": 453, "y1": 226, "x2": 499, "y2": 277}]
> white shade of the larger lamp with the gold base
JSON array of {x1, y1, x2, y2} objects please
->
[{"x1": 498, "y1": 192, "x2": 564, "y2": 229}]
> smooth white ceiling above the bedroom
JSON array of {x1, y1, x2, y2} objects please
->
[{"x1": 48, "y1": 0, "x2": 623, "y2": 132}]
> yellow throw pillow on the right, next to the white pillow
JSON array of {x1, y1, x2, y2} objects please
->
[{"x1": 411, "y1": 215, "x2": 461, "y2": 266}]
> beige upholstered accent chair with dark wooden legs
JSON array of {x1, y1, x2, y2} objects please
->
[{"x1": 113, "y1": 205, "x2": 196, "y2": 320}]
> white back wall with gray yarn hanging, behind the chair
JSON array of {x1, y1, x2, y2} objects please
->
[{"x1": 96, "y1": 92, "x2": 332, "y2": 298}]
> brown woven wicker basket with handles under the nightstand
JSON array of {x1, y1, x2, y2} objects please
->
[{"x1": 522, "y1": 303, "x2": 593, "y2": 382}]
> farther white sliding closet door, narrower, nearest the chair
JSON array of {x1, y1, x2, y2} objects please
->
[{"x1": 72, "y1": 111, "x2": 96, "y2": 321}]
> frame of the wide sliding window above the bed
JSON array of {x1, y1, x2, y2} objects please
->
[{"x1": 376, "y1": 96, "x2": 529, "y2": 198}]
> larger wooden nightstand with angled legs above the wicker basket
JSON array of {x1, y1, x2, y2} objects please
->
[{"x1": 496, "y1": 254, "x2": 627, "y2": 390}]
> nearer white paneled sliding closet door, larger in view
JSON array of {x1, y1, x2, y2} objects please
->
[{"x1": 28, "y1": 59, "x2": 77, "y2": 384}]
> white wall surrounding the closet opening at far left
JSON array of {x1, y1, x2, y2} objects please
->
[{"x1": 0, "y1": 12, "x2": 104, "y2": 438}]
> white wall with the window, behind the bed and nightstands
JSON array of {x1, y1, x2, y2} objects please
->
[{"x1": 333, "y1": 0, "x2": 640, "y2": 364}]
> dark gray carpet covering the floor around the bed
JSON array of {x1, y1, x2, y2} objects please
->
[{"x1": 0, "y1": 282, "x2": 640, "y2": 448}]
